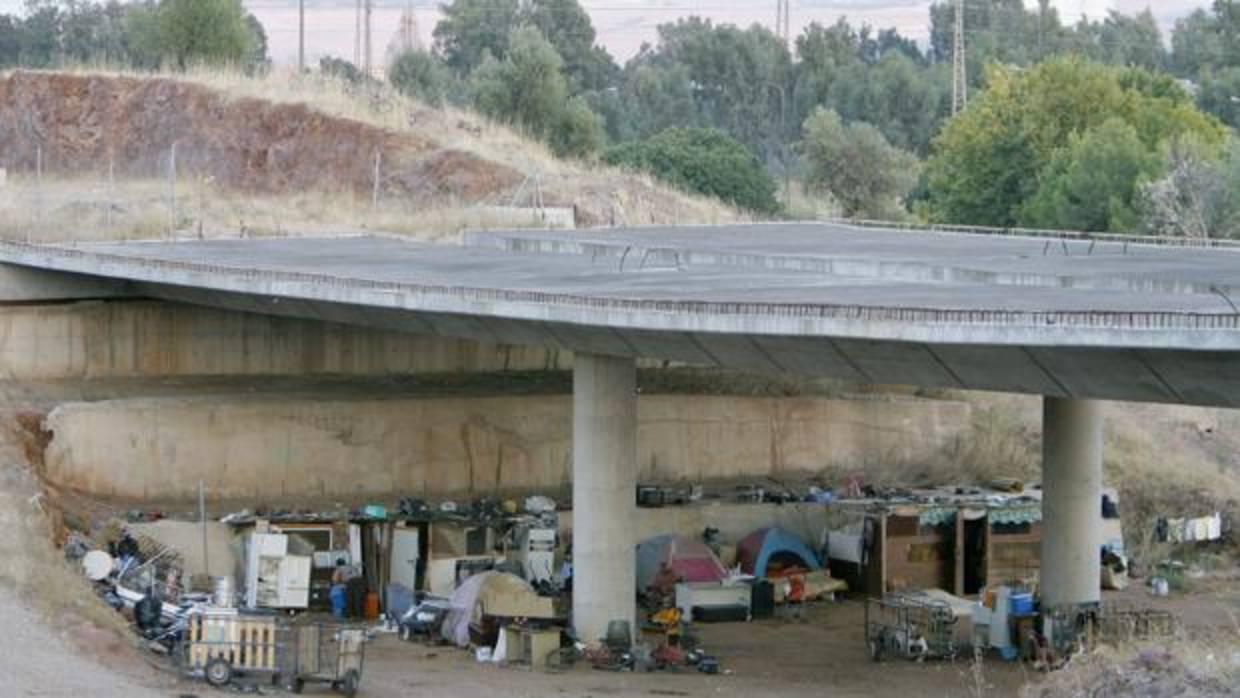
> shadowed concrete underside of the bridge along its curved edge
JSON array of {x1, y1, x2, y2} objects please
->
[{"x1": 145, "y1": 283, "x2": 1240, "y2": 408}]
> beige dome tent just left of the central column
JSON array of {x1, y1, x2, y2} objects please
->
[{"x1": 440, "y1": 572, "x2": 554, "y2": 647}]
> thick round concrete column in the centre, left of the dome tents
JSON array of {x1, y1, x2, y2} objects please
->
[{"x1": 573, "y1": 353, "x2": 637, "y2": 643}]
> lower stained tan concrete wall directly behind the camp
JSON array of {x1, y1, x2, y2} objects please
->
[{"x1": 45, "y1": 395, "x2": 968, "y2": 501}]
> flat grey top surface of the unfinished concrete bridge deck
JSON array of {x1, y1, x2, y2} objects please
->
[{"x1": 43, "y1": 226, "x2": 1240, "y2": 315}]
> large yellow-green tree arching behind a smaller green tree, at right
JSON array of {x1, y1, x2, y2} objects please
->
[{"x1": 926, "y1": 58, "x2": 1224, "y2": 227}]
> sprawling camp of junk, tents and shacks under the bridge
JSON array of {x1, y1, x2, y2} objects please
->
[{"x1": 55, "y1": 479, "x2": 1190, "y2": 688}]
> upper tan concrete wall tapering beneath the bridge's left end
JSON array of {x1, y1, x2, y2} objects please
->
[{"x1": 0, "y1": 301, "x2": 572, "y2": 379}]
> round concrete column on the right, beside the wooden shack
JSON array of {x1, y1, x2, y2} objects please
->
[{"x1": 1040, "y1": 397, "x2": 1102, "y2": 607}]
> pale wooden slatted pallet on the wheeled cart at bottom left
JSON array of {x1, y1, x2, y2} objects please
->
[{"x1": 187, "y1": 615, "x2": 279, "y2": 671}]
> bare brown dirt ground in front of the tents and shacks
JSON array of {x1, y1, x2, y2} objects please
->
[{"x1": 365, "y1": 601, "x2": 1034, "y2": 698}]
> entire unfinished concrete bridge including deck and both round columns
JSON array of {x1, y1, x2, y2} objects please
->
[{"x1": 0, "y1": 223, "x2": 1240, "y2": 638}]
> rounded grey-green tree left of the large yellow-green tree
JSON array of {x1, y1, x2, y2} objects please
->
[{"x1": 801, "y1": 108, "x2": 918, "y2": 218}]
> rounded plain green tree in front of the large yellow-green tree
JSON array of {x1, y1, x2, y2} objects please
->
[{"x1": 1019, "y1": 119, "x2": 1162, "y2": 233}]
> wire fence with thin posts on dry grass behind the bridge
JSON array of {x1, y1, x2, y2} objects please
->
[{"x1": 0, "y1": 145, "x2": 577, "y2": 243}]
